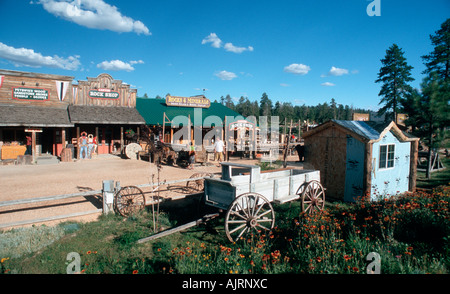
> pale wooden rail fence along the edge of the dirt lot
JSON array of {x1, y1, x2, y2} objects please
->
[{"x1": 0, "y1": 176, "x2": 209, "y2": 229}]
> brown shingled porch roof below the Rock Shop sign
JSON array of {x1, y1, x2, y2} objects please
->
[{"x1": 69, "y1": 105, "x2": 145, "y2": 125}]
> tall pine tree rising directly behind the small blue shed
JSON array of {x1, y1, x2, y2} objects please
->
[{"x1": 375, "y1": 44, "x2": 414, "y2": 122}]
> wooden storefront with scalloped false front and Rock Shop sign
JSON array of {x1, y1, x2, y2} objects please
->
[{"x1": 68, "y1": 73, "x2": 145, "y2": 155}]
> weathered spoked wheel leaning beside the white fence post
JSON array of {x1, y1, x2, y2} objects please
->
[{"x1": 114, "y1": 186, "x2": 145, "y2": 217}]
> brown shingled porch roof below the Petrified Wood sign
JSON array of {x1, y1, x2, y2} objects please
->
[{"x1": 0, "y1": 104, "x2": 73, "y2": 127}]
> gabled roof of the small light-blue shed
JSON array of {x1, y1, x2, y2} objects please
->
[{"x1": 303, "y1": 119, "x2": 419, "y2": 143}]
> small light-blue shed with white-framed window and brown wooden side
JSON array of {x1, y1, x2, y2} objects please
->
[{"x1": 303, "y1": 120, "x2": 419, "y2": 201}]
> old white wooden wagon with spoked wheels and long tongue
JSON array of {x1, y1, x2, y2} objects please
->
[{"x1": 132, "y1": 162, "x2": 325, "y2": 243}]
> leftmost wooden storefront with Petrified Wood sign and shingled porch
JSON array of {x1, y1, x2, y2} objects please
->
[{"x1": 0, "y1": 70, "x2": 73, "y2": 159}]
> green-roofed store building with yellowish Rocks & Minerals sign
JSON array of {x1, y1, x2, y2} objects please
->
[{"x1": 137, "y1": 95, "x2": 256, "y2": 151}]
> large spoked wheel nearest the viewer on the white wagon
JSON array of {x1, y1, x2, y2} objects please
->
[{"x1": 225, "y1": 192, "x2": 275, "y2": 242}]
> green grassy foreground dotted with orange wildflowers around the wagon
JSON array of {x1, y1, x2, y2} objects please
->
[{"x1": 0, "y1": 163, "x2": 450, "y2": 274}]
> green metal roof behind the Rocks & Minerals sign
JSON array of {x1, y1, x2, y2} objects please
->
[{"x1": 136, "y1": 98, "x2": 242, "y2": 126}]
